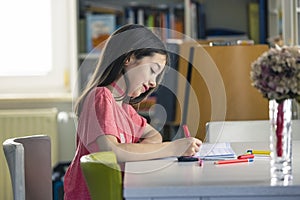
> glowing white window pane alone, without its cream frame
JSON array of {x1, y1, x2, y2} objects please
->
[{"x1": 0, "y1": 0, "x2": 52, "y2": 76}]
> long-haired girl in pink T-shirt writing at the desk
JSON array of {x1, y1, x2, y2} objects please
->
[{"x1": 64, "y1": 25, "x2": 201, "y2": 200}]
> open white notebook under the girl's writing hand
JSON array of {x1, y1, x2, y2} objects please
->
[{"x1": 195, "y1": 142, "x2": 236, "y2": 160}]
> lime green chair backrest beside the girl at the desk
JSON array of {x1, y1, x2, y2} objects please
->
[{"x1": 80, "y1": 151, "x2": 122, "y2": 200}]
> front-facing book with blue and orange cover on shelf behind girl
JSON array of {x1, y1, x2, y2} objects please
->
[{"x1": 86, "y1": 13, "x2": 116, "y2": 52}]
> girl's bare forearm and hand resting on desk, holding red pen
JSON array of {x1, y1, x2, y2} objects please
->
[{"x1": 97, "y1": 135, "x2": 202, "y2": 162}]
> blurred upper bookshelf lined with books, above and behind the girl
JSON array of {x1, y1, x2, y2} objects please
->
[{"x1": 77, "y1": 0, "x2": 270, "y2": 55}]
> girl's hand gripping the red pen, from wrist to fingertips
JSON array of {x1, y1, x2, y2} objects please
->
[{"x1": 173, "y1": 137, "x2": 202, "y2": 156}]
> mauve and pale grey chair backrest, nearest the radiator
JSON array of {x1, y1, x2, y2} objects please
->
[{"x1": 3, "y1": 135, "x2": 52, "y2": 200}]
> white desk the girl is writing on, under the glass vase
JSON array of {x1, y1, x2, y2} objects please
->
[{"x1": 123, "y1": 141, "x2": 300, "y2": 200}]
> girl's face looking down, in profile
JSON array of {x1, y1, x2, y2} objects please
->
[{"x1": 125, "y1": 53, "x2": 166, "y2": 98}]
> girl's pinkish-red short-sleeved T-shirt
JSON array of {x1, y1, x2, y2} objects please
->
[{"x1": 64, "y1": 87, "x2": 147, "y2": 200}]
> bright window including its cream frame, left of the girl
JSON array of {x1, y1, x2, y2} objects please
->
[{"x1": 0, "y1": 0, "x2": 76, "y2": 94}]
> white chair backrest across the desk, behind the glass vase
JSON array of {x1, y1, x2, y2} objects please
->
[{"x1": 206, "y1": 120, "x2": 300, "y2": 142}]
